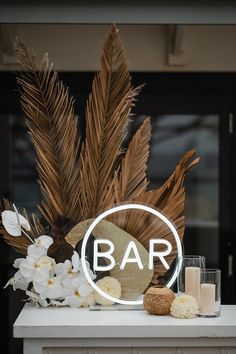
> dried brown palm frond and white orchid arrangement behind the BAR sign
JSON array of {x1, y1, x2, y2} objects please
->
[{"x1": 0, "y1": 25, "x2": 199, "y2": 306}]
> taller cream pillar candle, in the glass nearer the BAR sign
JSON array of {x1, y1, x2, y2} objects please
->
[{"x1": 185, "y1": 267, "x2": 200, "y2": 303}]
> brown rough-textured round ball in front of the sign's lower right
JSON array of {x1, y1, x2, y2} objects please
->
[{"x1": 143, "y1": 287, "x2": 175, "y2": 315}]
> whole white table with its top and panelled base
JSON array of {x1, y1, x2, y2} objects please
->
[{"x1": 14, "y1": 304, "x2": 236, "y2": 354}]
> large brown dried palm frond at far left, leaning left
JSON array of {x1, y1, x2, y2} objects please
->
[{"x1": 16, "y1": 41, "x2": 80, "y2": 223}]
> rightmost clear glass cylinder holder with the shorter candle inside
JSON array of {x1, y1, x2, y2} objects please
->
[{"x1": 199, "y1": 268, "x2": 221, "y2": 317}]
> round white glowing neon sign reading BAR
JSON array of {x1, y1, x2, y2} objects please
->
[{"x1": 81, "y1": 204, "x2": 182, "y2": 305}]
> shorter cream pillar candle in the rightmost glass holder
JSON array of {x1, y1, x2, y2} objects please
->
[{"x1": 200, "y1": 284, "x2": 216, "y2": 316}]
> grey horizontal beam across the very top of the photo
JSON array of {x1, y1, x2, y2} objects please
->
[{"x1": 0, "y1": 0, "x2": 236, "y2": 24}]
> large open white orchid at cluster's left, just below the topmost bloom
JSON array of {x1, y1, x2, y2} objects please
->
[{"x1": 19, "y1": 256, "x2": 50, "y2": 282}]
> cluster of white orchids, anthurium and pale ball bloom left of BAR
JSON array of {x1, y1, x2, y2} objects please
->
[{"x1": 2, "y1": 206, "x2": 121, "y2": 308}]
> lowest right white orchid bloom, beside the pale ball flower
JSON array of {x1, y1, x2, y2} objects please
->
[{"x1": 61, "y1": 283, "x2": 93, "y2": 308}]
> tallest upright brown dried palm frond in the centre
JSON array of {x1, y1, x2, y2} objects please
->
[{"x1": 80, "y1": 25, "x2": 137, "y2": 219}]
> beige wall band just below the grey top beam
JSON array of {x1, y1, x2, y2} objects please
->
[{"x1": 0, "y1": 25, "x2": 236, "y2": 71}]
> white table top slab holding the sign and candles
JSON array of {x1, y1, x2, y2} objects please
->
[{"x1": 14, "y1": 304, "x2": 236, "y2": 338}]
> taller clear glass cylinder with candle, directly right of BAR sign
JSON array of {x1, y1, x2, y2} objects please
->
[{"x1": 177, "y1": 255, "x2": 205, "y2": 305}]
